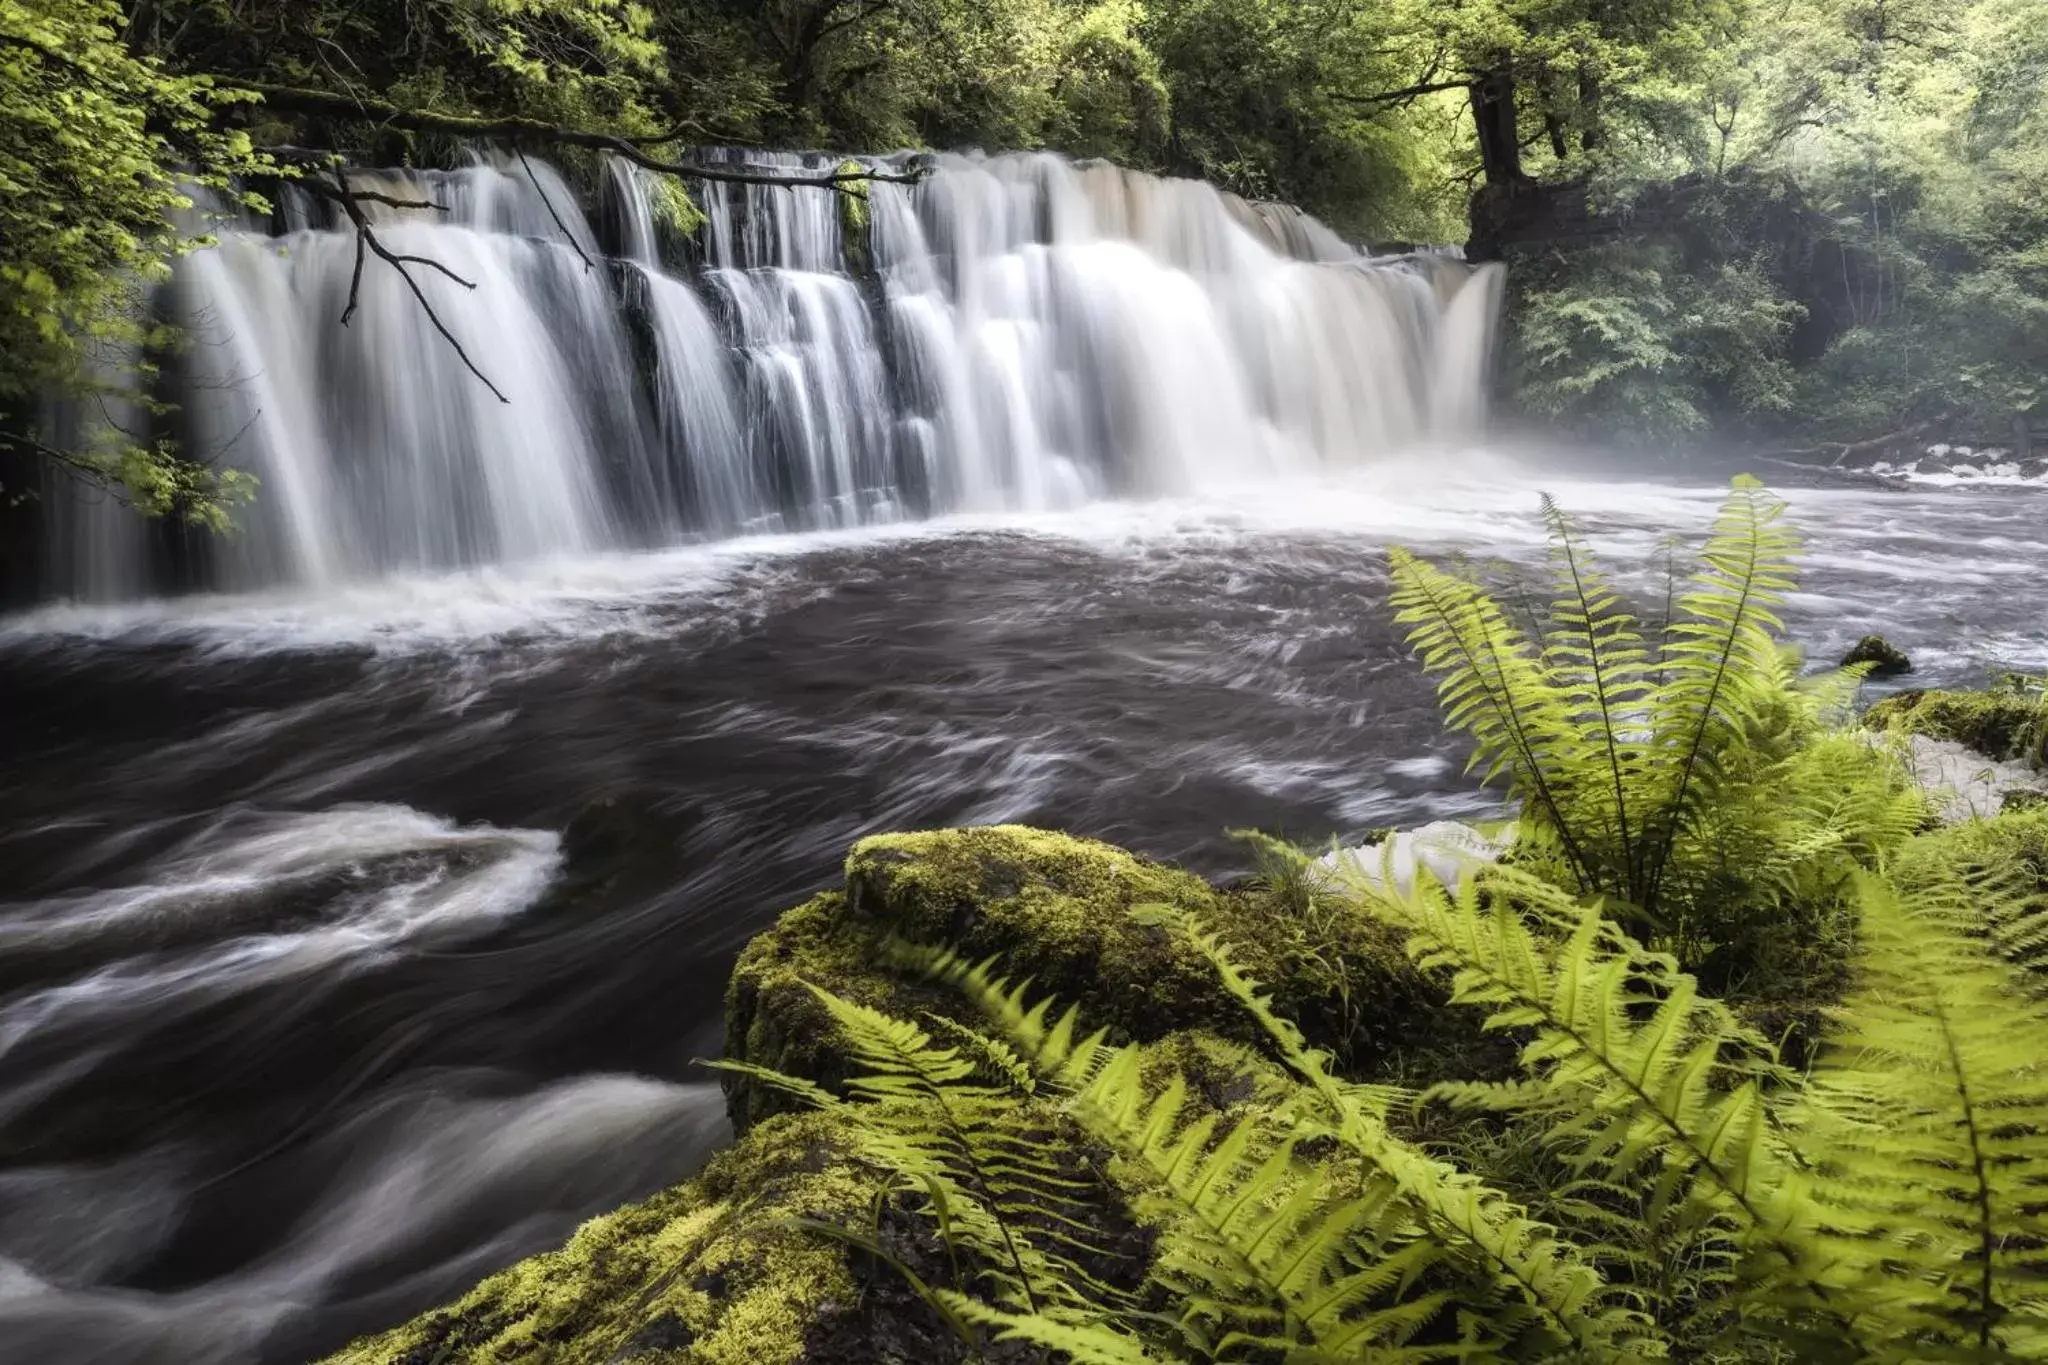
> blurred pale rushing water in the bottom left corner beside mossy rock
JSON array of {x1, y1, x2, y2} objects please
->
[{"x1": 0, "y1": 1074, "x2": 725, "y2": 1365}]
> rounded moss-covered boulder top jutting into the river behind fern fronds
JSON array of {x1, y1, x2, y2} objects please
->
[{"x1": 725, "y1": 825, "x2": 1468, "y2": 1130}]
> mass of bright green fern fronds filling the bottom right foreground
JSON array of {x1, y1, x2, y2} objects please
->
[{"x1": 737, "y1": 843, "x2": 2048, "y2": 1363}]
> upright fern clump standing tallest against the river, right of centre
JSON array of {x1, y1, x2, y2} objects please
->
[{"x1": 1391, "y1": 477, "x2": 1919, "y2": 982}]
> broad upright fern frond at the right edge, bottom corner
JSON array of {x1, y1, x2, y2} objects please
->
[{"x1": 1806, "y1": 876, "x2": 2048, "y2": 1361}]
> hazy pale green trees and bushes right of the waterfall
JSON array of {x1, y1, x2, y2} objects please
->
[{"x1": 1516, "y1": 0, "x2": 2048, "y2": 444}]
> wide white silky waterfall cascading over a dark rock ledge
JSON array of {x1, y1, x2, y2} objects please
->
[{"x1": 32, "y1": 151, "x2": 1499, "y2": 598}]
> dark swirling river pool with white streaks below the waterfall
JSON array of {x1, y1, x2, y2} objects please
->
[{"x1": 0, "y1": 467, "x2": 2048, "y2": 1363}]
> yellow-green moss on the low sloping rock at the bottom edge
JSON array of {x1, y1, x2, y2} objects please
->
[{"x1": 317, "y1": 1113, "x2": 881, "y2": 1365}]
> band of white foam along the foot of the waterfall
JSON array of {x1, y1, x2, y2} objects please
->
[{"x1": 0, "y1": 462, "x2": 2048, "y2": 671}]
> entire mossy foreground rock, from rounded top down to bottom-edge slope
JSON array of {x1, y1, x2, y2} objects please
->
[{"x1": 330, "y1": 827, "x2": 1513, "y2": 1365}]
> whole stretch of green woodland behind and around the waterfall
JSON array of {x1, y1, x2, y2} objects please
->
[{"x1": 0, "y1": 0, "x2": 2048, "y2": 520}]
